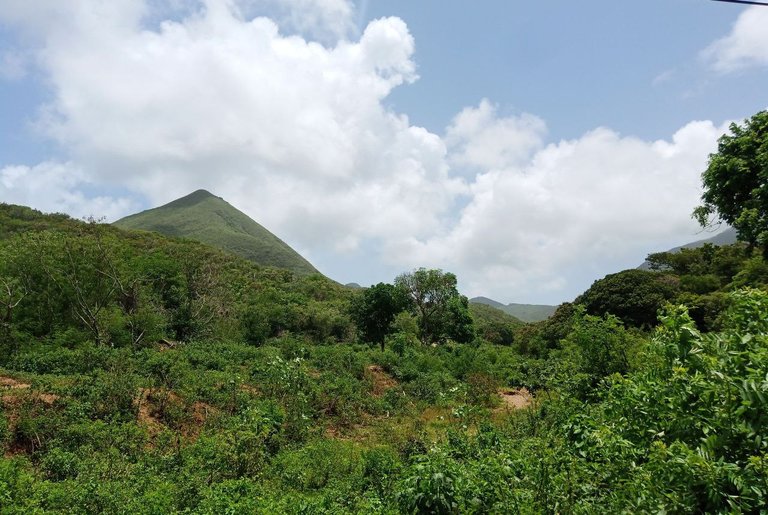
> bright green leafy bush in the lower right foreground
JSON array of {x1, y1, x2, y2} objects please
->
[{"x1": 572, "y1": 290, "x2": 768, "y2": 512}]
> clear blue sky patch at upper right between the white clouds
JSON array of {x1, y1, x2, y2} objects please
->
[{"x1": 367, "y1": 0, "x2": 768, "y2": 139}]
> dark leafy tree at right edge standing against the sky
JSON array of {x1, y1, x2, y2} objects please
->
[{"x1": 693, "y1": 111, "x2": 768, "y2": 256}]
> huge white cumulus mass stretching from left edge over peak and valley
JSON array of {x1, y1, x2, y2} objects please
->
[{"x1": 0, "y1": 0, "x2": 722, "y2": 301}]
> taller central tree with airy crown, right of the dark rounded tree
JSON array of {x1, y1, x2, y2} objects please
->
[{"x1": 395, "y1": 268, "x2": 474, "y2": 344}]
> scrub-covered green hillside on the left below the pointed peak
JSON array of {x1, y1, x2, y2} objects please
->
[{"x1": 0, "y1": 212, "x2": 352, "y2": 348}]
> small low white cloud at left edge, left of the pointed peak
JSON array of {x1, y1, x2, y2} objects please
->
[{"x1": 0, "y1": 162, "x2": 137, "y2": 221}]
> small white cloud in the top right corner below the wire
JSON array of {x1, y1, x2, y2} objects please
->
[{"x1": 702, "y1": 6, "x2": 768, "y2": 73}]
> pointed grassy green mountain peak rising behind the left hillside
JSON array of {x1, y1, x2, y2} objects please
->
[{"x1": 114, "y1": 190, "x2": 318, "y2": 275}]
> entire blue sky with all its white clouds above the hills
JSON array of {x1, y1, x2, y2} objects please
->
[{"x1": 0, "y1": 0, "x2": 768, "y2": 304}]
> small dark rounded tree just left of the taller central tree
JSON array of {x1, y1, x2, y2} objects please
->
[{"x1": 351, "y1": 283, "x2": 409, "y2": 350}]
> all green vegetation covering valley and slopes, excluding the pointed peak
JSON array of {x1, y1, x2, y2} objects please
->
[{"x1": 0, "y1": 112, "x2": 768, "y2": 514}]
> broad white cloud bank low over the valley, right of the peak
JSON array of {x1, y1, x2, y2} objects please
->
[{"x1": 393, "y1": 116, "x2": 725, "y2": 301}]
